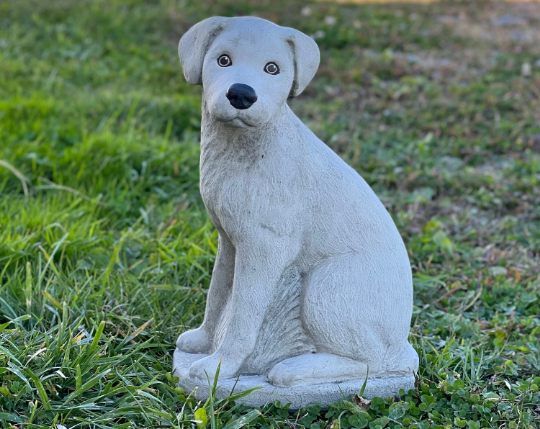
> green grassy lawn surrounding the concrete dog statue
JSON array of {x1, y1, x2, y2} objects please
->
[{"x1": 0, "y1": 0, "x2": 540, "y2": 429}]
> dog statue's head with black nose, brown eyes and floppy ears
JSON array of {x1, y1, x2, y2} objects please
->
[{"x1": 178, "y1": 17, "x2": 320, "y2": 127}]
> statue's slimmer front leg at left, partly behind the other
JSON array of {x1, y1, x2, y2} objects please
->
[{"x1": 176, "y1": 233, "x2": 235, "y2": 353}]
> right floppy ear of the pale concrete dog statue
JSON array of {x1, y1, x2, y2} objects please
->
[{"x1": 285, "y1": 28, "x2": 321, "y2": 97}]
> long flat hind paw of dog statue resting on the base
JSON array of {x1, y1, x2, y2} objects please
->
[{"x1": 268, "y1": 353, "x2": 368, "y2": 387}]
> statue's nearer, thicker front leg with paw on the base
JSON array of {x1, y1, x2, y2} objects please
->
[{"x1": 190, "y1": 230, "x2": 300, "y2": 380}]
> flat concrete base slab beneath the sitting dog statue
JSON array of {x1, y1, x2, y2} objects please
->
[{"x1": 173, "y1": 349, "x2": 415, "y2": 410}]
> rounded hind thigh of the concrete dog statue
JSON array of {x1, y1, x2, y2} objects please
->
[{"x1": 301, "y1": 252, "x2": 414, "y2": 377}]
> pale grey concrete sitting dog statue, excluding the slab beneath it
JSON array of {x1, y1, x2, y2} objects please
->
[{"x1": 175, "y1": 17, "x2": 418, "y2": 404}]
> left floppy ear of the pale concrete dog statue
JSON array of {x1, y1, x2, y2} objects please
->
[{"x1": 178, "y1": 16, "x2": 227, "y2": 85}]
